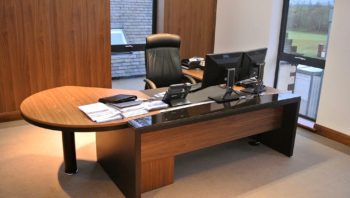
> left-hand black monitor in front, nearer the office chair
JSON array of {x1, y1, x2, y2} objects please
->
[{"x1": 202, "y1": 52, "x2": 243, "y2": 88}]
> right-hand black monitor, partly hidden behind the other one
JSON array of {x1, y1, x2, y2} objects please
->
[{"x1": 238, "y1": 48, "x2": 267, "y2": 80}]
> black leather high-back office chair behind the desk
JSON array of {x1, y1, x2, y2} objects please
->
[{"x1": 144, "y1": 33, "x2": 196, "y2": 89}]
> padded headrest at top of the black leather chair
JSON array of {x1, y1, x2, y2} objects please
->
[{"x1": 146, "y1": 33, "x2": 181, "y2": 49}]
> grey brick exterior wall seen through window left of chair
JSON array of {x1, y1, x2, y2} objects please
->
[{"x1": 110, "y1": 0, "x2": 153, "y2": 78}]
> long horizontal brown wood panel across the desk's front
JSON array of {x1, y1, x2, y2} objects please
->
[{"x1": 141, "y1": 107, "x2": 283, "y2": 162}]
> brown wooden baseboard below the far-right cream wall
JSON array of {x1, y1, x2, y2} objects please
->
[{"x1": 314, "y1": 124, "x2": 350, "y2": 146}]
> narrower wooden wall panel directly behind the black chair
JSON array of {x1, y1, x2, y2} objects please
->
[{"x1": 164, "y1": 0, "x2": 217, "y2": 58}]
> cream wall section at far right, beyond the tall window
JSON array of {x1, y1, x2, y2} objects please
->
[{"x1": 316, "y1": 0, "x2": 350, "y2": 135}]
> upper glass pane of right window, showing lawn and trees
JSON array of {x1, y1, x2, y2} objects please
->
[{"x1": 284, "y1": 0, "x2": 333, "y2": 59}]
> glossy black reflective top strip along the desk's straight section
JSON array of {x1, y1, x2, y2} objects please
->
[{"x1": 129, "y1": 86, "x2": 299, "y2": 130}]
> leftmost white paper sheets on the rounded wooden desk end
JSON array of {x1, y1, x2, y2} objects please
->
[{"x1": 79, "y1": 102, "x2": 123, "y2": 122}]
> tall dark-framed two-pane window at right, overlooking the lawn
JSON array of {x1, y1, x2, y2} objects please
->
[{"x1": 275, "y1": 0, "x2": 334, "y2": 120}]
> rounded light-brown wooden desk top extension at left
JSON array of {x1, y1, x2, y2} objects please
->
[{"x1": 20, "y1": 86, "x2": 158, "y2": 131}]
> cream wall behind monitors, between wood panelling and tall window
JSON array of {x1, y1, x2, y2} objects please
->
[{"x1": 214, "y1": 0, "x2": 283, "y2": 86}]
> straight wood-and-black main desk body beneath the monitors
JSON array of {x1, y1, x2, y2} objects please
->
[{"x1": 96, "y1": 86, "x2": 300, "y2": 197}]
